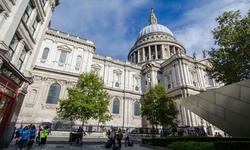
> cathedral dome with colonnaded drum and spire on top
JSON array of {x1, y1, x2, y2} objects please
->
[{"x1": 128, "y1": 8, "x2": 186, "y2": 64}]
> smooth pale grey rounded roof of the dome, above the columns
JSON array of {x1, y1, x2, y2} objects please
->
[{"x1": 138, "y1": 24, "x2": 174, "y2": 39}]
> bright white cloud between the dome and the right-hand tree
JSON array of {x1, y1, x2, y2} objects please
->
[{"x1": 175, "y1": 0, "x2": 250, "y2": 57}]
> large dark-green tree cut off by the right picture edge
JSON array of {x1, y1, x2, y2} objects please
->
[{"x1": 207, "y1": 10, "x2": 250, "y2": 85}]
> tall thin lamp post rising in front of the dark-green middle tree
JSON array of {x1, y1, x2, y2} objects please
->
[{"x1": 146, "y1": 63, "x2": 155, "y2": 138}]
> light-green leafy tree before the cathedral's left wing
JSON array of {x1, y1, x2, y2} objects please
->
[{"x1": 57, "y1": 73, "x2": 112, "y2": 123}]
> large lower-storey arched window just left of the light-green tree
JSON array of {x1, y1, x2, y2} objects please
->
[{"x1": 46, "y1": 83, "x2": 61, "y2": 104}]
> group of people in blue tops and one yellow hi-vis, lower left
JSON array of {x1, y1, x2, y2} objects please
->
[{"x1": 14, "y1": 124, "x2": 49, "y2": 150}]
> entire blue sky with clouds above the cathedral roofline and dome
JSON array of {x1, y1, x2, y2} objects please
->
[{"x1": 51, "y1": 0, "x2": 250, "y2": 60}]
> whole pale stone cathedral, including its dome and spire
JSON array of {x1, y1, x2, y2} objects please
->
[{"x1": 18, "y1": 9, "x2": 220, "y2": 134}]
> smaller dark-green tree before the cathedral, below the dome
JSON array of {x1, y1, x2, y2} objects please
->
[{"x1": 141, "y1": 84, "x2": 179, "y2": 127}]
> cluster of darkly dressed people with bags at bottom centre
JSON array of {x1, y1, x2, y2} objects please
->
[{"x1": 107, "y1": 128, "x2": 129, "y2": 149}]
